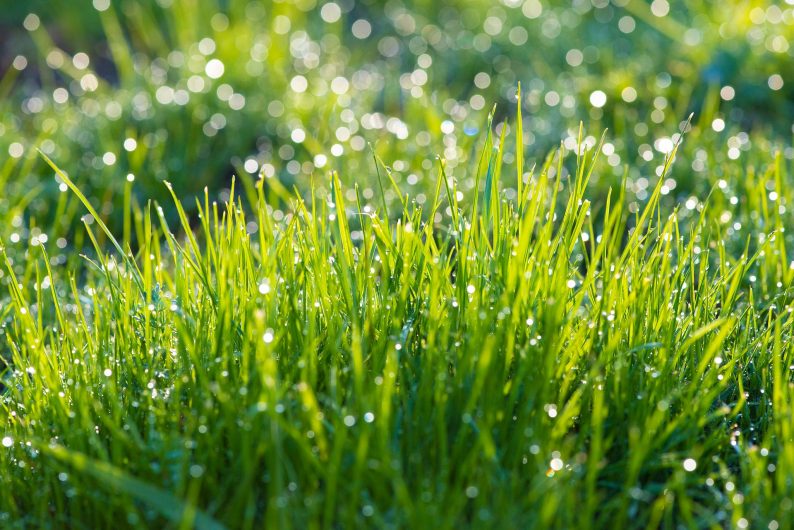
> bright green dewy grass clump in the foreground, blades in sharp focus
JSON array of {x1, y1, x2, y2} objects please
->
[{"x1": 0, "y1": 103, "x2": 794, "y2": 528}]
